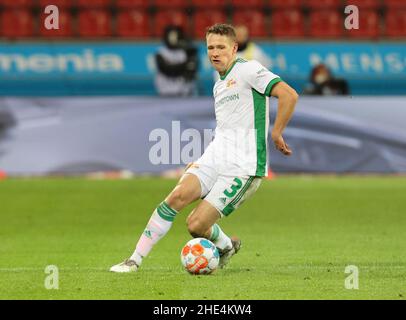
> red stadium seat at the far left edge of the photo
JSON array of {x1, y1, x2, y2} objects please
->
[{"x1": 0, "y1": 9, "x2": 35, "y2": 38}]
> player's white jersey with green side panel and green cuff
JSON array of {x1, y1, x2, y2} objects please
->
[{"x1": 196, "y1": 58, "x2": 281, "y2": 177}]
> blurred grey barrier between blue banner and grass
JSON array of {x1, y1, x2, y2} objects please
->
[{"x1": 0, "y1": 96, "x2": 406, "y2": 176}]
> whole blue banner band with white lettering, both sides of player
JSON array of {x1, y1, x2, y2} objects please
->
[{"x1": 0, "y1": 42, "x2": 406, "y2": 96}]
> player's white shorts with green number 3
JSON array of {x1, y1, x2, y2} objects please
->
[{"x1": 185, "y1": 163, "x2": 262, "y2": 217}]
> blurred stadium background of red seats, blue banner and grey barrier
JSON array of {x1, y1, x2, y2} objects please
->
[{"x1": 0, "y1": 0, "x2": 406, "y2": 175}]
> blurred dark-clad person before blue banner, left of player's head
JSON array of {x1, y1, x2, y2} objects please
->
[{"x1": 155, "y1": 26, "x2": 198, "y2": 97}]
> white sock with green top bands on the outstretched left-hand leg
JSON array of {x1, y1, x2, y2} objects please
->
[{"x1": 130, "y1": 201, "x2": 178, "y2": 266}]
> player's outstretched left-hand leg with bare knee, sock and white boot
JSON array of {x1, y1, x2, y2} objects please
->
[{"x1": 110, "y1": 173, "x2": 201, "y2": 272}]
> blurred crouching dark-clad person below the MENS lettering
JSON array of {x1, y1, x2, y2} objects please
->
[{"x1": 304, "y1": 64, "x2": 349, "y2": 96}]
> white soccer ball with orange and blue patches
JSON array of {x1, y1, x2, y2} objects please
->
[{"x1": 180, "y1": 238, "x2": 220, "y2": 274}]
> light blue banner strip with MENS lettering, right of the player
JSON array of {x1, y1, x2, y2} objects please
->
[{"x1": 263, "y1": 42, "x2": 406, "y2": 77}]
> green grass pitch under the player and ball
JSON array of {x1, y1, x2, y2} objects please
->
[{"x1": 0, "y1": 176, "x2": 406, "y2": 300}]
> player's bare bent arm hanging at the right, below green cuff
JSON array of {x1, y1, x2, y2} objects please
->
[{"x1": 271, "y1": 81, "x2": 299, "y2": 156}]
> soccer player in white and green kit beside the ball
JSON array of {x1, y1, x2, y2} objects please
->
[{"x1": 110, "y1": 24, "x2": 298, "y2": 272}]
